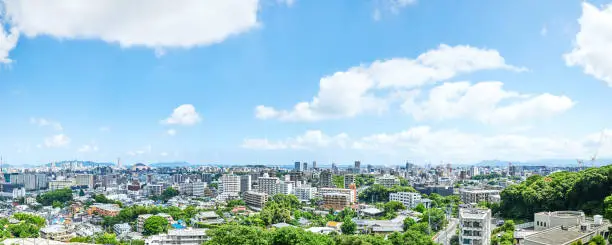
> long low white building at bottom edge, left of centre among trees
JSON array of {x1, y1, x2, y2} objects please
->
[{"x1": 145, "y1": 228, "x2": 208, "y2": 245}]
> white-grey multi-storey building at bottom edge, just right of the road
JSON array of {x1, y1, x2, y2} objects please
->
[{"x1": 459, "y1": 208, "x2": 491, "y2": 245}]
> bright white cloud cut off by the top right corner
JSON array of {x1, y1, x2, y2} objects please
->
[{"x1": 564, "y1": 2, "x2": 612, "y2": 86}]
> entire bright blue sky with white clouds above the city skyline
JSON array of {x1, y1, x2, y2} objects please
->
[{"x1": 0, "y1": 0, "x2": 612, "y2": 165}]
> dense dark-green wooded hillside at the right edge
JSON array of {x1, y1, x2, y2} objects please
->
[{"x1": 500, "y1": 165, "x2": 612, "y2": 219}]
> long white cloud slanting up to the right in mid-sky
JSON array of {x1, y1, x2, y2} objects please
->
[{"x1": 255, "y1": 44, "x2": 525, "y2": 121}]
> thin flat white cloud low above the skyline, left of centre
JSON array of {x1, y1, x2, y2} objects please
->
[{"x1": 242, "y1": 130, "x2": 349, "y2": 150}]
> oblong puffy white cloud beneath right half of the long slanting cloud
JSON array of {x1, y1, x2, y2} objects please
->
[{"x1": 402, "y1": 81, "x2": 575, "y2": 124}]
